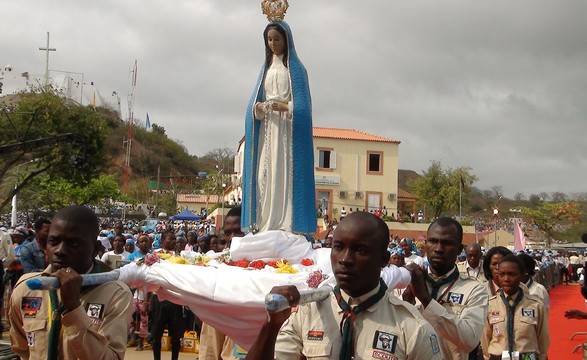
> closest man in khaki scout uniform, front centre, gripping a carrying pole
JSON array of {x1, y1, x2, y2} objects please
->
[{"x1": 247, "y1": 212, "x2": 442, "y2": 360}]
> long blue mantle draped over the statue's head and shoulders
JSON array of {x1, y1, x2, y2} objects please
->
[{"x1": 241, "y1": 21, "x2": 317, "y2": 234}]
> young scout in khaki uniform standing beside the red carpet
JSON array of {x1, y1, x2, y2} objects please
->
[{"x1": 481, "y1": 254, "x2": 550, "y2": 360}]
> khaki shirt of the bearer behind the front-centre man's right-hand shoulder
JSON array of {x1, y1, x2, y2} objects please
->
[{"x1": 416, "y1": 270, "x2": 488, "y2": 360}]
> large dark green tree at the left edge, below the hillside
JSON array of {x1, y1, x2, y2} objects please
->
[{"x1": 0, "y1": 92, "x2": 107, "y2": 211}]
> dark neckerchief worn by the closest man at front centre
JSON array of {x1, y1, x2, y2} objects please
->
[{"x1": 334, "y1": 279, "x2": 387, "y2": 360}]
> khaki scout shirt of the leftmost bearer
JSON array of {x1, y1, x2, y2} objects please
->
[{"x1": 9, "y1": 267, "x2": 132, "y2": 360}]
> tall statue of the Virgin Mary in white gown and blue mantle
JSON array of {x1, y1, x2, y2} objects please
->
[{"x1": 241, "y1": 14, "x2": 316, "y2": 234}]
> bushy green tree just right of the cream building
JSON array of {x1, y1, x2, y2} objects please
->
[{"x1": 410, "y1": 160, "x2": 478, "y2": 217}]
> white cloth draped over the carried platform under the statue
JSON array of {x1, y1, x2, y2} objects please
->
[{"x1": 115, "y1": 231, "x2": 410, "y2": 349}]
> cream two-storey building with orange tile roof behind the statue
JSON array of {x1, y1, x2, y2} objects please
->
[{"x1": 231, "y1": 127, "x2": 406, "y2": 220}]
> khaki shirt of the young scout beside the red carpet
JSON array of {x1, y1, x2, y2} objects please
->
[{"x1": 481, "y1": 284, "x2": 550, "y2": 360}]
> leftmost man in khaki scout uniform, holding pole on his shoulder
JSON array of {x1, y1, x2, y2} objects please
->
[{"x1": 9, "y1": 206, "x2": 132, "y2": 359}]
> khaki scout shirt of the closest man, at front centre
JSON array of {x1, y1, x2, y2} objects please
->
[{"x1": 275, "y1": 286, "x2": 442, "y2": 360}]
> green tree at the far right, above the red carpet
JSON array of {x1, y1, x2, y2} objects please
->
[{"x1": 520, "y1": 201, "x2": 583, "y2": 247}]
